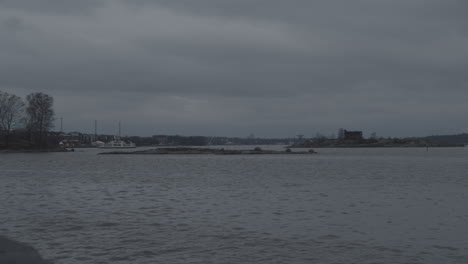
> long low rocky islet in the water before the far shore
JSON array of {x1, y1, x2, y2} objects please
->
[{"x1": 100, "y1": 147, "x2": 317, "y2": 155}]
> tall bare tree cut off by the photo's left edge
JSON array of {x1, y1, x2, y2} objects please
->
[{"x1": 0, "y1": 91, "x2": 24, "y2": 147}]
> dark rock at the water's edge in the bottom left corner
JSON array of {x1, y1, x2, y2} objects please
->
[{"x1": 0, "y1": 236, "x2": 50, "y2": 264}]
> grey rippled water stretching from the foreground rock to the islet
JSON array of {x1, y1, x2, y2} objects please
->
[{"x1": 0, "y1": 147, "x2": 468, "y2": 264}]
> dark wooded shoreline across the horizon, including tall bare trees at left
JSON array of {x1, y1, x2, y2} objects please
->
[{"x1": 0, "y1": 90, "x2": 468, "y2": 152}]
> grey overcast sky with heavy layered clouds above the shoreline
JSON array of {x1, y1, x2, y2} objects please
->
[{"x1": 0, "y1": 0, "x2": 468, "y2": 137}]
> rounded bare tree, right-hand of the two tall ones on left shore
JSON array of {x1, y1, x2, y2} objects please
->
[{"x1": 26, "y1": 93, "x2": 54, "y2": 146}]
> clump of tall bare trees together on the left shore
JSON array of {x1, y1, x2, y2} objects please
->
[{"x1": 0, "y1": 90, "x2": 55, "y2": 148}]
